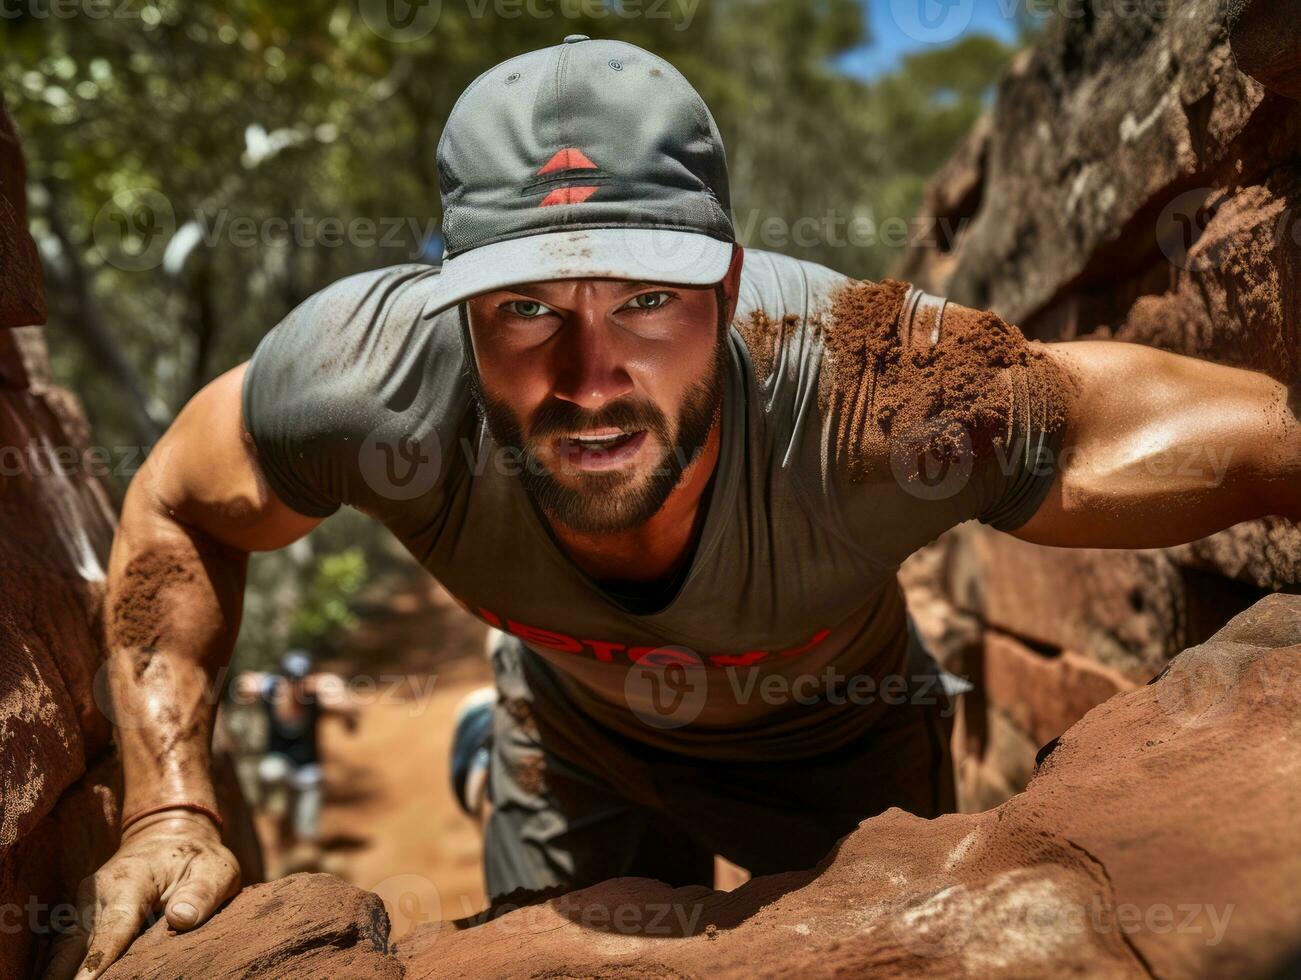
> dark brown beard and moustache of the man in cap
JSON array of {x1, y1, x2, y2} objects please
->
[{"x1": 471, "y1": 338, "x2": 726, "y2": 534}]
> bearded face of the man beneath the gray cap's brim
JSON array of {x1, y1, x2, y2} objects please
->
[{"x1": 468, "y1": 279, "x2": 726, "y2": 532}]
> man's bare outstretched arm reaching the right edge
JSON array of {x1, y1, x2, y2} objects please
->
[{"x1": 1016, "y1": 341, "x2": 1301, "y2": 548}]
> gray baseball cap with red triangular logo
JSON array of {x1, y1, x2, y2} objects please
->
[{"x1": 425, "y1": 35, "x2": 736, "y2": 314}]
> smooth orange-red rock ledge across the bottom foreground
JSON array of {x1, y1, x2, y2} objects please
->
[{"x1": 96, "y1": 595, "x2": 1301, "y2": 980}]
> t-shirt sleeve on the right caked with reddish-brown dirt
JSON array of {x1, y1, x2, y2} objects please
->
[{"x1": 820, "y1": 281, "x2": 1069, "y2": 564}]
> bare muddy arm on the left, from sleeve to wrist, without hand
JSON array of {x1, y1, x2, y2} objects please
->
[{"x1": 108, "y1": 367, "x2": 319, "y2": 813}]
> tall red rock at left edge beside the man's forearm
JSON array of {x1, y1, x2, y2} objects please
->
[{"x1": 0, "y1": 389, "x2": 113, "y2": 854}]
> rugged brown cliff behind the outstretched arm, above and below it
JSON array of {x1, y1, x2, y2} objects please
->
[{"x1": 899, "y1": 0, "x2": 1301, "y2": 808}]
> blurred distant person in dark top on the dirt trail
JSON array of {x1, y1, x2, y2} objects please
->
[{"x1": 235, "y1": 649, "x2": 358, "y2": 867}]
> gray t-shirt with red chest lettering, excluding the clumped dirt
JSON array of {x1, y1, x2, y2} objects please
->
[{"x1": 243, "y1": 250, "x2": 1054, "y2": 759}]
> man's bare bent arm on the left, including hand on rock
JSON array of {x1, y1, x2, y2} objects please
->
[{"x1": 49, "y1": 366, "x2": 319, "y2": 980}]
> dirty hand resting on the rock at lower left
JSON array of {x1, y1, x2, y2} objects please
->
[{"x1": 44, "y1": 810, "x2": 239, "y2": 980}]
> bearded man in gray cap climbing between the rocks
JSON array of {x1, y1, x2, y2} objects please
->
[{"x1": 48, "y1": 36, "x2": 1301, "y2": 976}]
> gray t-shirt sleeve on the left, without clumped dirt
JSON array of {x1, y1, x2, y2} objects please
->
[{"x1": 243, "y1": 265, "x2": 467, "y2": 518}]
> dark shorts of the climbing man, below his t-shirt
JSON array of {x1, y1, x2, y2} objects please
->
[{"x1": 484, "y1": 635, "x2": 954, "y2": 898}]
